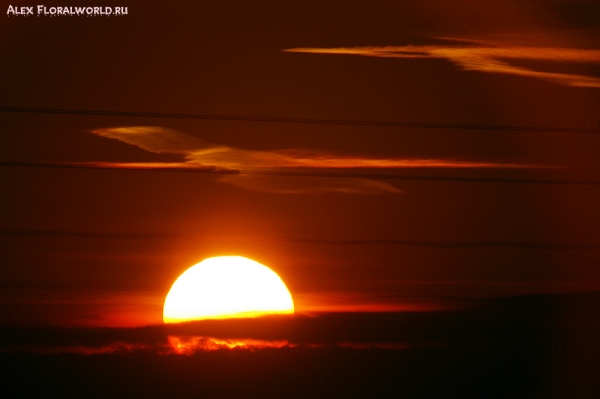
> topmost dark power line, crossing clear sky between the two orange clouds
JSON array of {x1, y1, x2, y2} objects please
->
[{"x1": 0, "y1": 107, "x2": 600, "y2": 134}]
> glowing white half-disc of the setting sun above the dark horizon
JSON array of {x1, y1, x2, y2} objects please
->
[{"x1": 163, "y1": 256, "x2": 294, "y2": 323}]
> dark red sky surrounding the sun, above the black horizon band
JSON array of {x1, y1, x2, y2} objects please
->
[{"x1": 0, "y1": 0, "x2": 600, "y2": 325}]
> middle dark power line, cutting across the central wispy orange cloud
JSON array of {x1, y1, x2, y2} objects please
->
[{"x1": 0, "y1": 162, "x2": 600, "y2": 186}]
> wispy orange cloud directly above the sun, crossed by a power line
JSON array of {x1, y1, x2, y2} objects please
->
[{"x1": 86, "y1": 126, "x2": 534, "y2": 194}]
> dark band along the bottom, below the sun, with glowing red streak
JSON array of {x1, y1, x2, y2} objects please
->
[{"x1": 0, "y1": 291, "x2": 600, "y2": 398}]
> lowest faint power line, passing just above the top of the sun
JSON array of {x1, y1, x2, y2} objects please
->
[{"x1": 0, "y1": 230, "x2": 600, "y2": 251}]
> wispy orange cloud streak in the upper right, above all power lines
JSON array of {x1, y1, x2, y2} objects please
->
[{"x1": 284, "y1": 37, "x2": 600, "y2": 88}]
